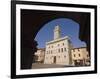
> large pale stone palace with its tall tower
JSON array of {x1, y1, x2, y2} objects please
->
[{"x1": 44, "y1": 26, "x2": 72, "y2": 65}]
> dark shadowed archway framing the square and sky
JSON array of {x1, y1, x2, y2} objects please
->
[{"x1": 21, "y1": 9, "x2": 90, "y2": 69}]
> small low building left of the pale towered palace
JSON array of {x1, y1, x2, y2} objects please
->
[{"x1": 34, "y1": 48, "x2": 45, "y2": 63}]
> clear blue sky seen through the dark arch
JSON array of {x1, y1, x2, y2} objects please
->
[{"x1": 35, "y1": 18, "x2": 86, "y2": 48}]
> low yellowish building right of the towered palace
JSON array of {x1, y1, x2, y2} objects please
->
[{"x1": 71, "y1": 47, "x2": 90, "y2": 66}]
